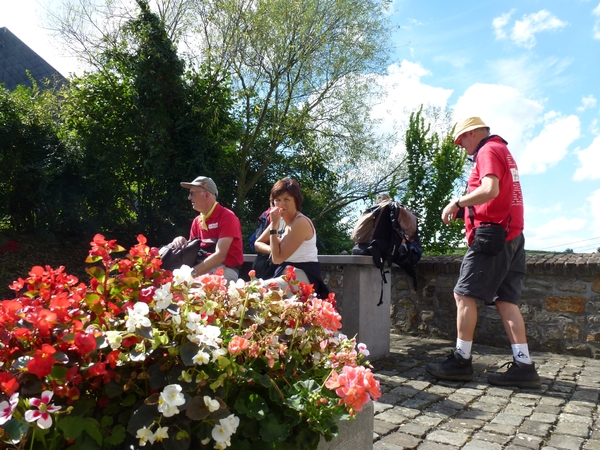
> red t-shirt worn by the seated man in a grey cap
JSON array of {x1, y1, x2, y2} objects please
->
[{"x1": 190, "y1": 203, "x2": 244, "y2": 267}]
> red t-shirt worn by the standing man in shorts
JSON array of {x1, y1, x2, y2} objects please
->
[{"x1": 465, "y1": 136, "x2": 525, "y2": 245}]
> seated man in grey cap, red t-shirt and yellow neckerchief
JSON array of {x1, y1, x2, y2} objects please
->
[{"x1": 171, "y1": 176, "x2": 244, "y2": 281}]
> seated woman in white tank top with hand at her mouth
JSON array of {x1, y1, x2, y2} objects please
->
[{"x1": 254, "y1": 178, "x2": 328, "y2": 298}]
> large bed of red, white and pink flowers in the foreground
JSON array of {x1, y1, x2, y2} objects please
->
[{"x1": 0, "y1": 235, "x2": 381, "y2": 450}]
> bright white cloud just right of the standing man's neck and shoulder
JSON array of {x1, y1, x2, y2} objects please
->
[{"x1": 519, "y1": 112, "x2": 580, "y2": 174}]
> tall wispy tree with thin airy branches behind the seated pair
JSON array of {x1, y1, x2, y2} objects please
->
[{"x1": 44, "y1": 0, "x2": 396, "y2": 239}]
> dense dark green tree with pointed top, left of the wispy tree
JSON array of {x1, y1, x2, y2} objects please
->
[{"x1": 56, "y1": 0, "x2": 233, "y2": 240}]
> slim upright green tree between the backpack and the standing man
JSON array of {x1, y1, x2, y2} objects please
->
[{"x1": 402, "y1": 106, "x2": 466, "y2": 254}]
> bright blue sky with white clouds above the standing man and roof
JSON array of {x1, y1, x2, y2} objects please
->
[{"x1": 0, "y1": 0, "x2": 600, "y2": 252}]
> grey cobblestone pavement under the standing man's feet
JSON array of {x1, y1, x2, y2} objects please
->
[{"x1": 373, "y1": 334, "x2": 600, "y2": 450}]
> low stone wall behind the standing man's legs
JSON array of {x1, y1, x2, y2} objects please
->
[{"x1": 384, "y1": 253, "x2": 600, "y2": 359}]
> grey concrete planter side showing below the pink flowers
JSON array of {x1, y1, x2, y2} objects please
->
[{"x1": 317, "y1": 401, "x2": 375, "y2": 450}]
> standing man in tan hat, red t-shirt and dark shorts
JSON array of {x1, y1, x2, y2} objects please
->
[{"x1": 426, "y1": 117, "x2": 541, "y2": 388}]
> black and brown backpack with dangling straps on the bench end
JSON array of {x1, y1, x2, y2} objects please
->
[{"x1": 351, "y1": 201, "x2": 423, "y2": 306}]
